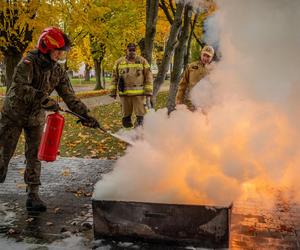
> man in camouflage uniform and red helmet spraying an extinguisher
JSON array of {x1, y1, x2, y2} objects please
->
[{"x1": 0, "y1": 27, "x2": 99, "y2": 211}]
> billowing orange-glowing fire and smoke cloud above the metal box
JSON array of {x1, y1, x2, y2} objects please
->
[{"x1": 94, "y1": 96, "x2": 297, "y2": 205}]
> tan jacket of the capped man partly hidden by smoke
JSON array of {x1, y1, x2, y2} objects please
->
[{"x1": 176, "y1": 61, "x2": 208, "y2": 108}]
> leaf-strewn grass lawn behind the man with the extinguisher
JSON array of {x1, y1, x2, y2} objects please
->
[{"x1": 15, "y1": 92, "x2": 167, "y2": 159}]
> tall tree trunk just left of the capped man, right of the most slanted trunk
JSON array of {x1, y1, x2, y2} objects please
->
[{"x1": 167, "y1": 5, "x2": 192, "y2": 113}]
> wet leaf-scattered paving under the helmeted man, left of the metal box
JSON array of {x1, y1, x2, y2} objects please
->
[{"x1": 0, "y1": 158, "x2": 113, "y2": 249}]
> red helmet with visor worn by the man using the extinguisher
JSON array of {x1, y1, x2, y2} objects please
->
[{"x1": 37, "y1": 27, "x2": 71, "y2": 54}]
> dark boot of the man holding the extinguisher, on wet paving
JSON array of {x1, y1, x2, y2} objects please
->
[{"x1": 26, "y1": 185, "x2": 47, "y2": 212}]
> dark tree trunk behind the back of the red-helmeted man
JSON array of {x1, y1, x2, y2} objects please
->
[{"x1": 4, "y1": 51, "x2": 22, "y2": 91}]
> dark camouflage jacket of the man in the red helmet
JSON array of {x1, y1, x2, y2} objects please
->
[{"x1": 2, "y1": 50, "x2": 88, "y2": 126}]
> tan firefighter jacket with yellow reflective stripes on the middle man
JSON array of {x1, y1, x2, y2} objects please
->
[{"x1": 111, "y1": 56, "x2": 153, "y2": 96}]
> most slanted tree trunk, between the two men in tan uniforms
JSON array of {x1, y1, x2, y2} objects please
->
[{"x1": 153, "y1": 2, "x2": 185, "y2": 103}]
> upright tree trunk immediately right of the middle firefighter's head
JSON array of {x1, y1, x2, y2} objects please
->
[{"x1": 144, "y1": 0, "x2": 159, "y2": 65}]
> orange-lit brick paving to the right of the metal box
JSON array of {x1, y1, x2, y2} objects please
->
[{"x1": 231, "y1": 196, "x2": 300, "y2": 250}]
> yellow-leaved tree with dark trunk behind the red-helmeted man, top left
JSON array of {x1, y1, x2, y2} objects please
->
[{"x1": 0, "y1": 0, "x2": 68, "y2": 88}]
